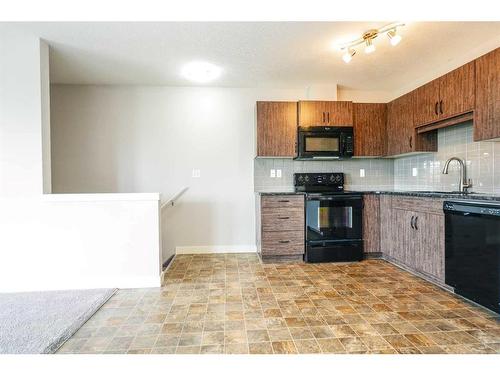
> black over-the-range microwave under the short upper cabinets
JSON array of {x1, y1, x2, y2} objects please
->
[{"x1": 295, "y1": 126, "x2": 354, "y2": 160}]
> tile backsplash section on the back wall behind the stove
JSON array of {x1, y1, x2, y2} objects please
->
[{"x1": 254, "y1": 159, "x2": 394, "y2": 191}]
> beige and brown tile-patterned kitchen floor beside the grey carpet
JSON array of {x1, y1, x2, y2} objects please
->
[{"x1": 59, "y1": 254, "x2": 500, "y2": 354}]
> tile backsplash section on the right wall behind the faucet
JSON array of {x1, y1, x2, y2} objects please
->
[{"x1": 394, "y1": 122, "x2": 500, "y2": 193}]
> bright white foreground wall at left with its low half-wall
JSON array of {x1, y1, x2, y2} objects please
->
[{"x1": 0, "y1": 32, "x2": 160, "y2": 292}]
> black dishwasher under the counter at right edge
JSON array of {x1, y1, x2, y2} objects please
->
[{"x1": 443, "y1": 201, "x2": 500, "y2": 313}]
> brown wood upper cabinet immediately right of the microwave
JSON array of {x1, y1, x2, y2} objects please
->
[{"x1": 353, "y1": 103, "x2": 387, "y2": 156}]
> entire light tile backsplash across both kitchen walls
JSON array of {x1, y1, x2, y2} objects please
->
[{"x1": 254, "y1": 122, "x2": 500, "y2": 194}]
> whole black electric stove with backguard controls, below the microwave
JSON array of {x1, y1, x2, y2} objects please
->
[{"x1": 293, "y1": 173, "x2": 363, "y2": 263}]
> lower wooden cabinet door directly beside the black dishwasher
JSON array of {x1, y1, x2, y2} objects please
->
[{"x1": 415, "y1": 213, "x2": 444, "y2": 282}]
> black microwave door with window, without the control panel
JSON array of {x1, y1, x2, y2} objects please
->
[{"x1": 297, "y1": 130, "x2": 342, "y2": 159}]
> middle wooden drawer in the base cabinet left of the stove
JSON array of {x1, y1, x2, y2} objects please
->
[{"x1": 261, "y1": 207, "x2": 304, "y2": 231}]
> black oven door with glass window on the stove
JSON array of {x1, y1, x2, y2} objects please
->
[{"x1": 306, "y1": 194, "x2": 363, "y2": 243}]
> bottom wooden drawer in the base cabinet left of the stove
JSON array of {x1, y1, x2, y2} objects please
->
[{"x1": 261, "y1": 230, "x2": 304, "y2": 256}]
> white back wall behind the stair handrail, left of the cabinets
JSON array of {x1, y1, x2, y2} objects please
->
[{"x1": 51, "y1": 85, "x2": 307, "y2": 259}]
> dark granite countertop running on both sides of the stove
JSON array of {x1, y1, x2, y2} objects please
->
[{"x1": 256, "y1": 190, "x2": 500, "y2": 201}]
